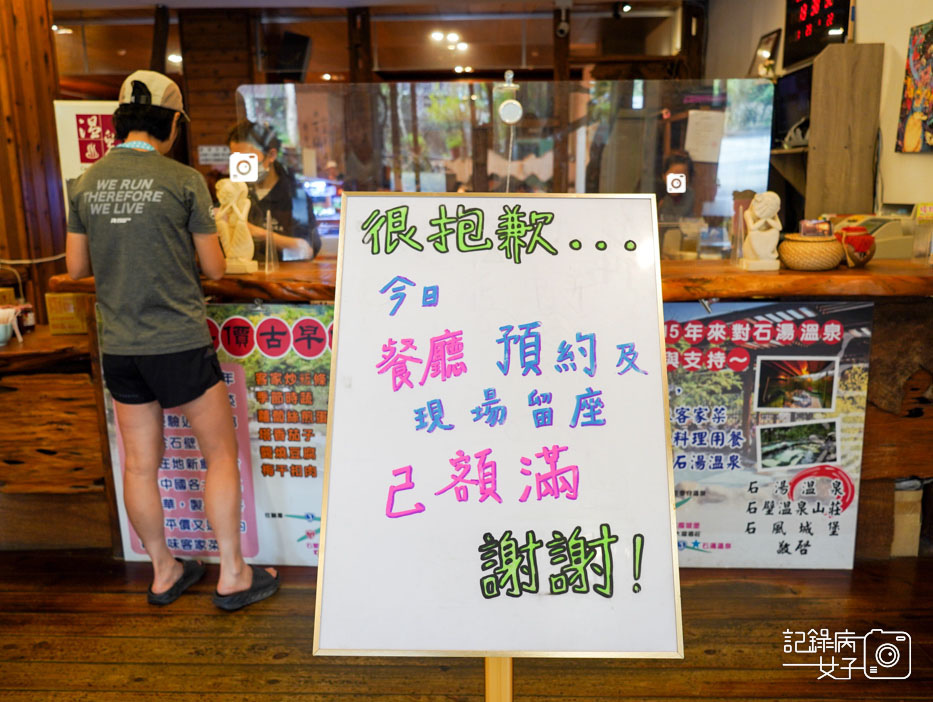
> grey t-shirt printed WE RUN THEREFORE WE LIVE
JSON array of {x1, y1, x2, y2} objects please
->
[{"x1": 68, "y1": 148, "x2": 217, "y2": 355}]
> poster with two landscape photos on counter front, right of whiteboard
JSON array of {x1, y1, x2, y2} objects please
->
[{"x1": 664, "y1": 301, "x2": 872, "y2": 568}]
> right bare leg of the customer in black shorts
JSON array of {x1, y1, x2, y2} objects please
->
[{"x1": 179, "y1": 382, "x2": 275, "y2": 595}]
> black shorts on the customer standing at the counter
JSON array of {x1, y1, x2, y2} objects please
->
[{"x1": 102, "y1": 346, "x2": 223, "y2": 407}]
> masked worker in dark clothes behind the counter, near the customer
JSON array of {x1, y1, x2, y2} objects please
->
[{"x1": 227, "y1": 120, "x2": 321, "y2": 261}]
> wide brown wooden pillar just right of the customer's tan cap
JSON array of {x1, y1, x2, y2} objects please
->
[{"x1": 178, "y1": 10, "x2": 255, "y2": 173}]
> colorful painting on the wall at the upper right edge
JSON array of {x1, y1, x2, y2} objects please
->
[{"x1": 895, "y1": 21, "x2": 933, "y2": 153}]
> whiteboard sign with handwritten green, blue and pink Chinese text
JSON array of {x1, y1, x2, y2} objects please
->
[{"x1": 314, "y1": 193, "x2": 683, "y2": 658}]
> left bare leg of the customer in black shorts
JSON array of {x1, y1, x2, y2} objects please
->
[{"x1": 113, "y1": 400, "x2": 182, "y2": 593}]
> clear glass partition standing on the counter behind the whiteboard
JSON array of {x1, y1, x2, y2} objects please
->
[{"x1": 226, "y1": 79, "x2": 773, "y2": 258}]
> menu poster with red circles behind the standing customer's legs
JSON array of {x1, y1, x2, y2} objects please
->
[{"x1": 104, "y1": 304, "x2": 333, "y2": 566}]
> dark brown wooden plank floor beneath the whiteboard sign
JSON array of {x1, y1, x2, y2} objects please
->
[{"x1": 0, "y1": 551, "x2": 933, "y2": 702}]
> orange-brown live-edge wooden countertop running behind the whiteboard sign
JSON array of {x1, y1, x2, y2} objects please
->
[{"x1": 49, "y1": 257, "x2": 933, "y2": 302}]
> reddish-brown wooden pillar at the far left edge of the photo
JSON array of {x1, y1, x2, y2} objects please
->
[{"x1": 0, "y1": 0, "x2": 65, "y2": 322}]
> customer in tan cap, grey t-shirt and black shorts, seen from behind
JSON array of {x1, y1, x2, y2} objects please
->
[{"x1": 65, "y1": 71, "x2": 279, "y2": 610}]
